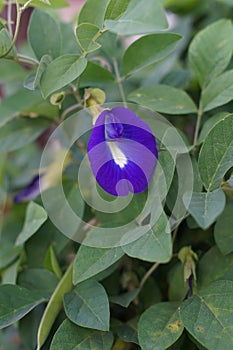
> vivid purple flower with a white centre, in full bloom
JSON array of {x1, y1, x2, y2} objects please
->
[{"x1": 87, "y1": 107, "x2": 158, "y2": 196}]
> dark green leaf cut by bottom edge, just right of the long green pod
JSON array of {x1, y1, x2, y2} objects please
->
[{"x1": 50, "y1": 319, "x2": 114, "y2": 350}]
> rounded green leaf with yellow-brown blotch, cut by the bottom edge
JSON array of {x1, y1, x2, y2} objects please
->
[{"x1": 138, "y1": 302, "x2": 184, "y2": 350}]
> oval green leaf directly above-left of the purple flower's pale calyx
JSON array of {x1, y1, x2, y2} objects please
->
[{"x1": 41, "y1": 55, "x2": 87, "y2": 98}]
